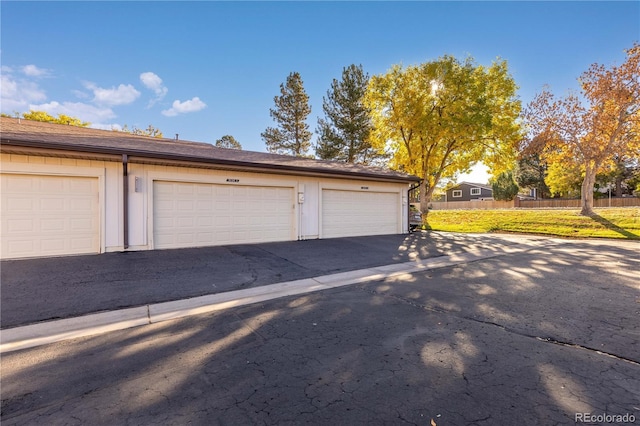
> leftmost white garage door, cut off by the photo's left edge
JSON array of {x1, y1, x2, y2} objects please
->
[{"x1": 1, "y1": 174, "x2": 100, "y2": 259}]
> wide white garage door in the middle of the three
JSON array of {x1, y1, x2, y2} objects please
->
[{"x1": 153, "y1": 181, "x2": 295, "y2": 248}]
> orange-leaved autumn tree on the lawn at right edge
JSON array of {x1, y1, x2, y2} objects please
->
[{"x1": 524, "y1": 43, "x2": 640, "y2": 216}]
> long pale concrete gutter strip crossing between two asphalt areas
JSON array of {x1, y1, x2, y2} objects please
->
[{"x1": 0, "y1": 244, "x2": 538, "y2": 353}]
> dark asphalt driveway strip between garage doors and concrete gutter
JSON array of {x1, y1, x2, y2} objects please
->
[{"x1": 0, "y1": 232, "x2": 539, "y2": 328}]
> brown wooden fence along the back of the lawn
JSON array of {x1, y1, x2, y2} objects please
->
[{"x1": 429, "y1": 197, "x2": 640, "y2": 210}]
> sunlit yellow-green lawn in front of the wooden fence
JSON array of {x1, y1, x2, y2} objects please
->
[{"x1": 424, "y1": 207, "x2": 640, "y2": 240}]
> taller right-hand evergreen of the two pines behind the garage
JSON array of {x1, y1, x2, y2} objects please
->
[{"x1": 316, "y1": 65, "x2": 382, "y2": 164}]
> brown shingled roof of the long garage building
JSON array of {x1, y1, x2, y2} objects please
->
[{"x1": 0, "y1": 117, "x2": 420, "y2": 182}]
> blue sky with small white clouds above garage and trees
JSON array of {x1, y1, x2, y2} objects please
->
[{"x1": 1, "y1": 1, "x2": 640, "y2": 176}]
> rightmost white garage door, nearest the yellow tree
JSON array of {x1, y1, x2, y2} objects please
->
[{"x1": 322, "y1": 189, "x2": 400, "y2": 238}]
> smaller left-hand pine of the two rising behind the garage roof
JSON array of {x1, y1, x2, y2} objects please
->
[{"x1": 261, "y1": 72, "x2": 311, "y2": 157}]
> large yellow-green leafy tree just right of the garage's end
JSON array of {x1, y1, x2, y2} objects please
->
[{"x1": 365, "y1": 56, "x2": 521, "y2": 214}]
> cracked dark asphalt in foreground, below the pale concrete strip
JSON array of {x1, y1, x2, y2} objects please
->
[{"x1": 0, "y1": 235, "x2": 640, "y2": 426}]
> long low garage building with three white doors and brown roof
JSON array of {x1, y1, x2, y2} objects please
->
[{"x1": 0, "y1": 117, "x2": 419, "y2": 259}]
